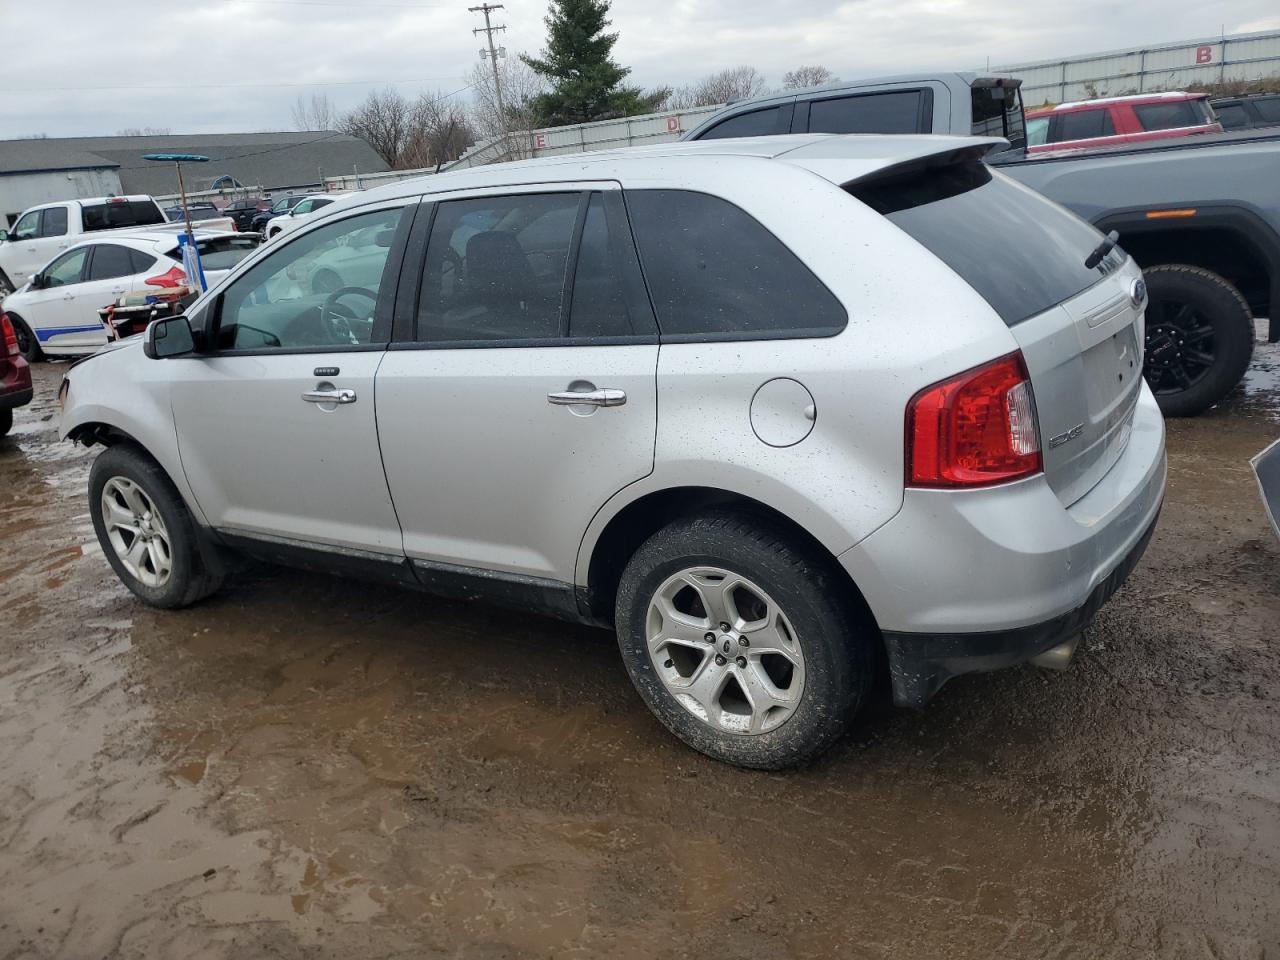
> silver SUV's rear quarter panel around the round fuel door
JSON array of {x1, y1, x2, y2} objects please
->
[{"x1": 577, "y1": 161, "x2": 1016, "y2": 584}]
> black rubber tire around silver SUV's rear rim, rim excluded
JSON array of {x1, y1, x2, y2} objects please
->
[{"x1": 616, "y1": 511, "x2": 881, "y2": 769}]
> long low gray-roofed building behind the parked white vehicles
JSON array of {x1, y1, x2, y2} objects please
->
[{"x1": 0, "y1": 131, "x2": 388, "y2": 224}]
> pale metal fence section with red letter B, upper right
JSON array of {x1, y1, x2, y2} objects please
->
[{"x1": 993, "y1": 31, "x2": 1280, "y2": 106}]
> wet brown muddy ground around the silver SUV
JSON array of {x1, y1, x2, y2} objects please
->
[{"x1": 0, "y1": 347, "x2": 1280, "y2": 960}]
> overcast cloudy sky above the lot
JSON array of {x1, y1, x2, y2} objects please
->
[{"x1": 0, "y1": 0, "x2": 1280, "y2": 138}]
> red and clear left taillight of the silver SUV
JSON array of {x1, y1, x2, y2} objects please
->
[{"x1": 906, "y1": 352, "x2": 1044, "y2": 488}]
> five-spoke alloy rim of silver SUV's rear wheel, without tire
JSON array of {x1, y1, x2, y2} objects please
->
[{"x1": 645, "y1": 567, "x2": 805, "y2": 735}]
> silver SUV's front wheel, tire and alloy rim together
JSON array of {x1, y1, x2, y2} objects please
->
[{"x1": 88, "y1": 444, "x2": 223, "y2": 609}]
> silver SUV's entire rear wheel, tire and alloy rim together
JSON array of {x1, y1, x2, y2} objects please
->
[{"x1": 616, "y1": 512, "x2": 879, "y2": 769}]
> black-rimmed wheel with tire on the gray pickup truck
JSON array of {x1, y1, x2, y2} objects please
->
[{"x1": 1143, "y1": 264, "x2": 1254, "y2": 416}]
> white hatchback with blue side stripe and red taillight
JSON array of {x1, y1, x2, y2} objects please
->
[{"x1": 0, "y1": 230, "x2": 260, "y2": 362}]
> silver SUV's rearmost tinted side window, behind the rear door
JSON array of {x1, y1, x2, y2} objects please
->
[{"x1": 627, "y1": 189, "x2": 849, "y2": 340}]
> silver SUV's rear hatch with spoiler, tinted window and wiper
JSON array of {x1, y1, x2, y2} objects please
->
[{"x1": 846, "y1": 159, "x2": 1143, "y2": 506}]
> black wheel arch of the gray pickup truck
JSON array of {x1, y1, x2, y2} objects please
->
[{"x1": 1094, "y1": 204, "x2": 1280, "y2": 342}]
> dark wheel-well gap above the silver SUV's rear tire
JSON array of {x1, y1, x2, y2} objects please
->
[{"x1": 579, "y1": 485, "x2": 878, "y2": 630}]
